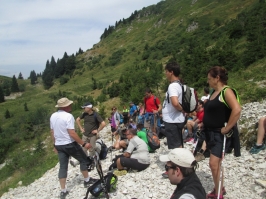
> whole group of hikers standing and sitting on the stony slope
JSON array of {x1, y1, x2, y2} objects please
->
[{"x1": 50, "y1": 62, "x2": 266, "y2": 199}]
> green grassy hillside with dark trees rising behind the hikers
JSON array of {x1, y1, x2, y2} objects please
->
[{"x1": 0, "y1": 0, "x2": 266, "y2": 195}]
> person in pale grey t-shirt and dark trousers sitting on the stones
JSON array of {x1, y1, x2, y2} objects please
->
[{"x1": 114, "y1": 128, "x2": 150, "y2": 176}]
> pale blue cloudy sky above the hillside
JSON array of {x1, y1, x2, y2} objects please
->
[{"x1": 0, "y1": 0, "x2": 161, "y2": 78}]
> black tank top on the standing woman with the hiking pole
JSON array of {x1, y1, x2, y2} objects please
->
[{"x1": 203, "y1": 92, "x2": 231, "y2": 128}]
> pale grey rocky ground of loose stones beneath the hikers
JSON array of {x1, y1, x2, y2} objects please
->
[{"x1": 1, "y1": 101, "x2": 266, "y2": 199}]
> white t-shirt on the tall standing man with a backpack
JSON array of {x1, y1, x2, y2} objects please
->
[{"x1": 162, "y1": 82, "x2": 185, "y2": 123}]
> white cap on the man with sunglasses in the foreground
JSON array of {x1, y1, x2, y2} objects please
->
[{"x1": 159, "y1": 148, "x2": 195, "y2": 168}]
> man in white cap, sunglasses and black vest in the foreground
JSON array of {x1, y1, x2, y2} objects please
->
[{"x1": 159, "y1": 148, "x2": 206, "y2": 199}]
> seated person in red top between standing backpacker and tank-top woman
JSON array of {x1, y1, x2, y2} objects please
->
[{"x1": 186, "y1": 100, "x2": 204, "y2": 142}]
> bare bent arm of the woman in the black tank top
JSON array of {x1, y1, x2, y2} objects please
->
[{"x1": 221, "y1": 89, "x2": 241, "y2": 134}]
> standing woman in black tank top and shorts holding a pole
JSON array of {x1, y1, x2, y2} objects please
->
[{"x1": 203, "y1": 66, "x2": 241, "y2": 198}]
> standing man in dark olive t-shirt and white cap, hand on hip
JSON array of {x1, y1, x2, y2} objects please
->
[{"x1": 76, "y1": 102, "x2": 105, "y2": 157}]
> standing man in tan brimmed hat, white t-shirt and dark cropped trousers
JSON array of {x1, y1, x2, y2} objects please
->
[{"x1": 50, "y1": 97, "x2": 96, "y2": 199}]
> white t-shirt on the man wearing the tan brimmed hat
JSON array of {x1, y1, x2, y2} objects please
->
[{"x1": 50, "y1": 110, "x2": 75, "y2": 145}]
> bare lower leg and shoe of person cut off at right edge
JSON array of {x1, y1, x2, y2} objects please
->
[{"x1": 249, "y1": 117, "x2": 266, "y2": 154}]
